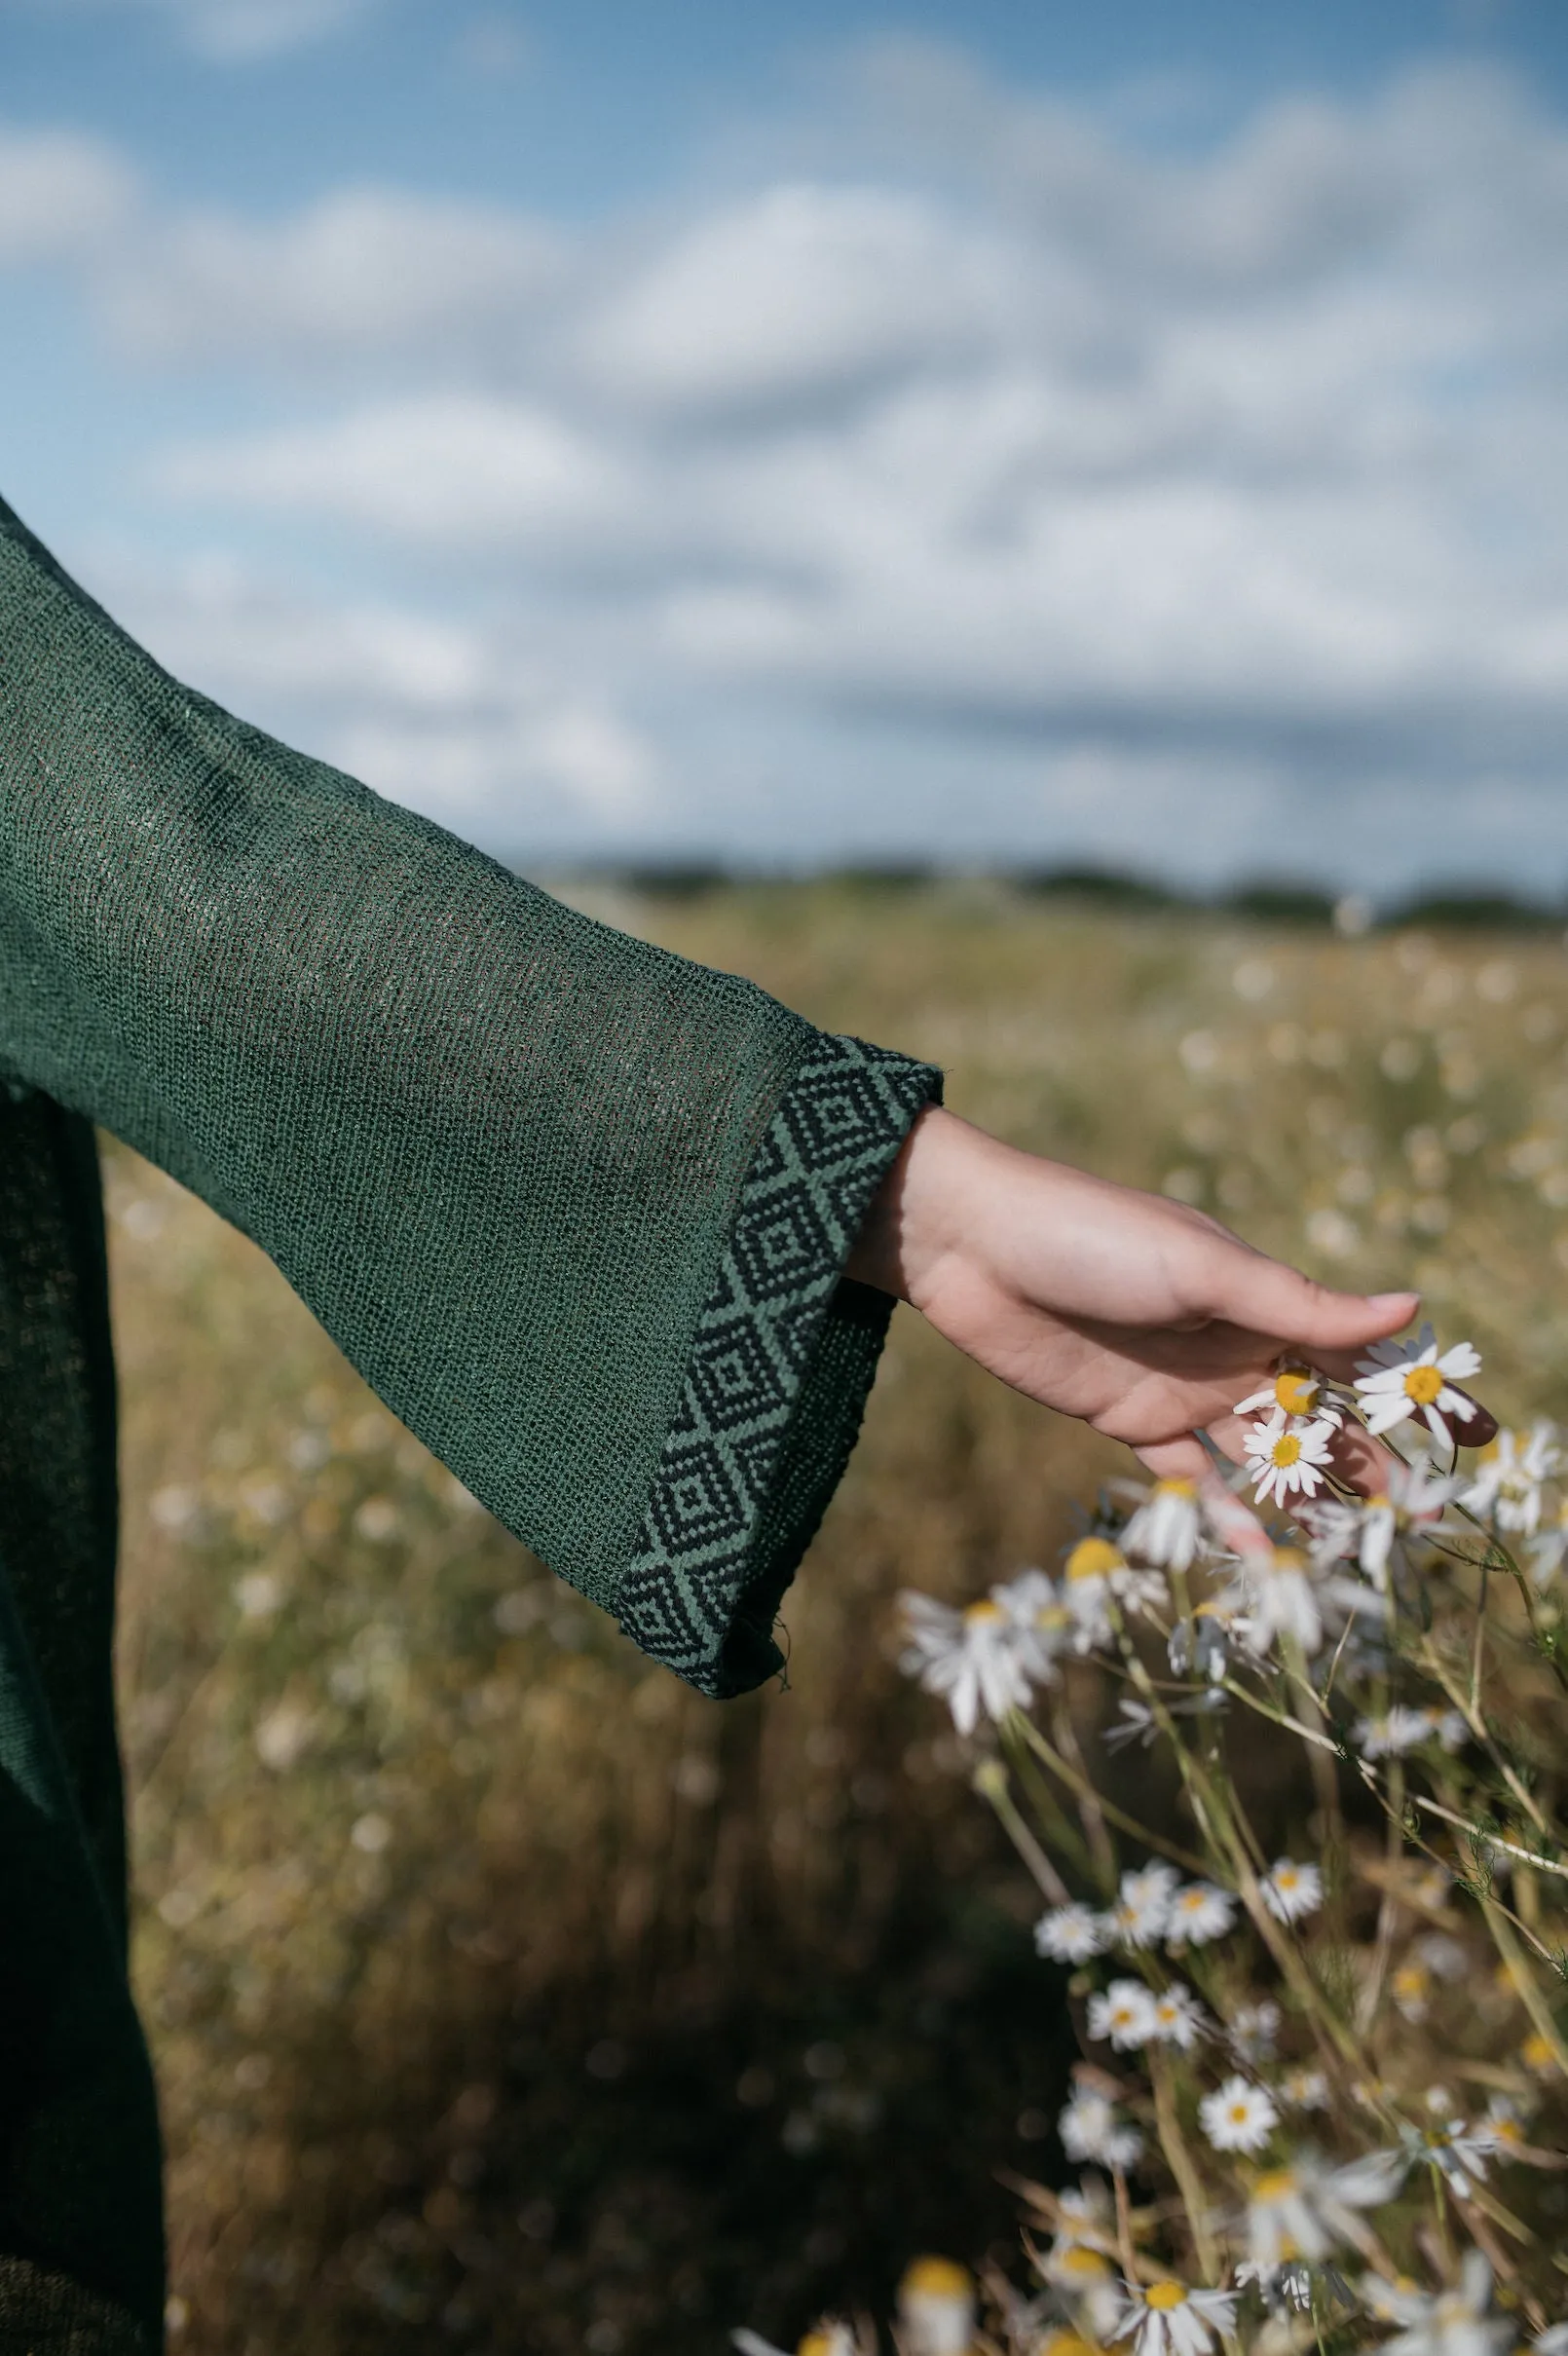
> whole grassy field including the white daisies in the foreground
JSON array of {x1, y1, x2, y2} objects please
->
[{"x1": 108, "y1": 883, "x2": 1568, "y2": 2356}]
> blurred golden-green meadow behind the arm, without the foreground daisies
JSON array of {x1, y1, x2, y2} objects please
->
[{"x1": 108, "y1": 883, "x2": 1568, "y2": 2356}]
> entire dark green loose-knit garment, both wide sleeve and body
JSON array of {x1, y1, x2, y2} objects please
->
[{"x1": 0, "y1": 502, "x2": 940, "y2": 2356}]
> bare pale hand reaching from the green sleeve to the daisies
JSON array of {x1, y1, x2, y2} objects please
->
[{"x1": 847, "y1": 1105, "x2": 1495, "y2": 1489}]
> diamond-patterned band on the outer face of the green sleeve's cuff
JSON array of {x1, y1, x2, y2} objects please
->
[{"x1": 616, "y1": 1036, "x2": 942, "y2": 1694}]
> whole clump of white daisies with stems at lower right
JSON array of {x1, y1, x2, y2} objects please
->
[{"x1": 861, "y1": 1328, "x2": 1568, "y2": 2356}]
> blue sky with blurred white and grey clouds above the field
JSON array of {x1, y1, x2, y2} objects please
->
[{"x1": 0, "y1": 0, "x2": 1568, "y2": 893}]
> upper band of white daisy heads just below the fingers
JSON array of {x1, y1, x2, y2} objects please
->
[{"x1": 899, "y1": 1327, "x2": 1568, "y2": 1760}]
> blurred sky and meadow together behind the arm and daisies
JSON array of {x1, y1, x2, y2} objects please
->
[{"x1": 0, "y1": 0, "x2": 1568, "y2": 2356}]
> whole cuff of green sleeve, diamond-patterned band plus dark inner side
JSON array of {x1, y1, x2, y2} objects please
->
[{"x1": 616, "y1": 1036, "x2": 942, "y2": 1697}]
